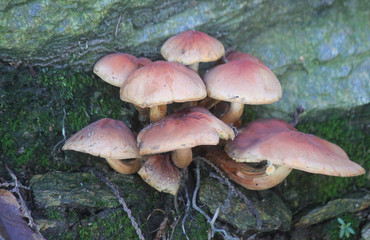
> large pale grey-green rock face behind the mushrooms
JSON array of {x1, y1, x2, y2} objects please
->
[{"x1": 0, "y1": 0, "x2": 370, "y2": 120}]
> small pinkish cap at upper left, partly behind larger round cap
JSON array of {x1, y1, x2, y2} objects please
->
[{"x1": 94, "y1": 53, "x2": 138, "y2": 87}]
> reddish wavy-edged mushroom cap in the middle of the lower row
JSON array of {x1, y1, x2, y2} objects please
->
[{"x1": 137, "y1": 107, "x2": 234, "y2": 155}]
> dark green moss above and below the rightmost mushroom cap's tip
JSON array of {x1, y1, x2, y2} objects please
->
[{"x1": 282, "y1": 114, "x2": 370, "y2": 207}]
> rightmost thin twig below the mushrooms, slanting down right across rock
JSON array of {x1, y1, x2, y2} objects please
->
[{"x1": 199, "y1": 157, "x2": 262, "y2": 229}]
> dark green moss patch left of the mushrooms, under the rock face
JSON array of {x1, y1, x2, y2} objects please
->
[{"x1": 0, "y1": 66, "x2": 126, "y2": 173}]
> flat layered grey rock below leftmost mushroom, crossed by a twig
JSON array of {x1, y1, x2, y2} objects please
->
[{"x1": 30, "y1": 172, "x2": 159, "y2": 212}]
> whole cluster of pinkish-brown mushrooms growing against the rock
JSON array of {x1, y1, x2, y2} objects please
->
[{"x1": 63, "y1": 30, "x2": 365, "y2": 195}]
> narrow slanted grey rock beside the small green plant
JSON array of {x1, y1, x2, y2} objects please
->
[{"x1": 296, "y1": 194, "x2": 370, "y2": 227}]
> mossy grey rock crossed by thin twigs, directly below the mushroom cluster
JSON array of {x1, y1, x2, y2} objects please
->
[{"x1": 199, "y1": 177, "x2": 292, "y2": 232}]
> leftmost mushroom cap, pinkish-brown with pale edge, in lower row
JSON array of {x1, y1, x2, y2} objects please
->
[{"x1": 63, "y1": 118, "x2": 140, "y2": 159}]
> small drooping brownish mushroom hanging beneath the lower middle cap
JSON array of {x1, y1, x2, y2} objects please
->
[{"x1": 138, "y1": 154, "x2": 181, "y2": 195}]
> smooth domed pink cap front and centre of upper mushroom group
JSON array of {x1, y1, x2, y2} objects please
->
[{"x1": 120, "y1": 61, "x2": 207, "y2": 108}]
